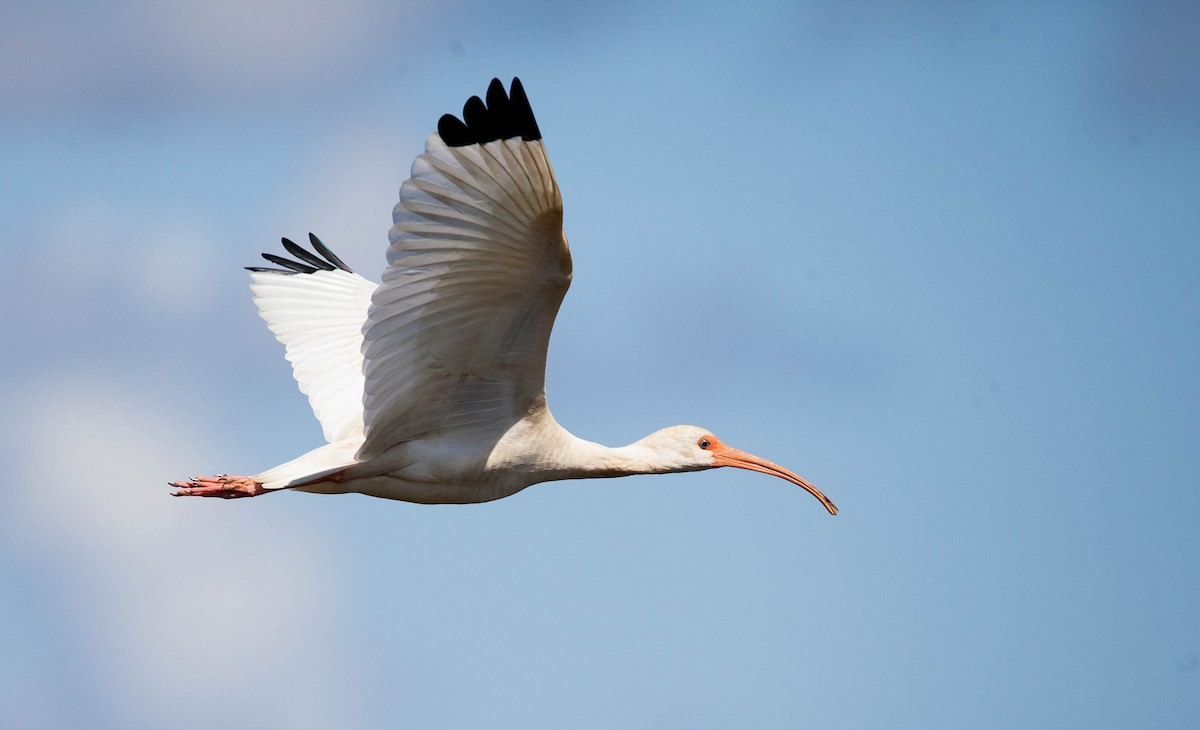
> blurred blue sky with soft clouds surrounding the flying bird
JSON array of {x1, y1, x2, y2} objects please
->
[{"x1": 0, "y1": 0, "x2": 1200, "y2": 728}]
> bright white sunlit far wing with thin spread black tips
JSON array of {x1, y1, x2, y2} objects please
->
[{"x1": 247, "y1": 233, "x2": 376, "y2": 443}]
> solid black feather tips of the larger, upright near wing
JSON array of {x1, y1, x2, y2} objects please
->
[{"x1": 438, "y1": 77, "x2": 541, "y2": 146}]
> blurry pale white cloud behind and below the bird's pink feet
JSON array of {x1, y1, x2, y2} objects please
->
[{"x1": 0, "y1": 381, "x2": 350, "y2": 726}]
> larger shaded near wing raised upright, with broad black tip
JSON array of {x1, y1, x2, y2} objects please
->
[{"x1": 359, "y1": 79, "x2": 571, "y2": 459}]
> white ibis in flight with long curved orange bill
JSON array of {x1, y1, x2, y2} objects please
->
[{"x1": 172, "y1": 79, "x2": 838, "y2": 514}]
